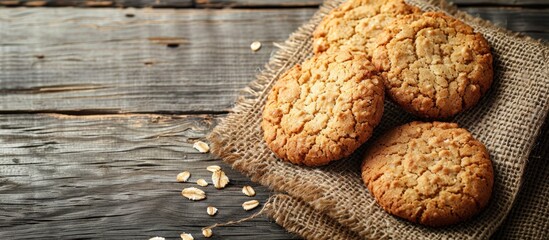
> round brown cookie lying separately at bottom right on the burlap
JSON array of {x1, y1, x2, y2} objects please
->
[{"x1": 362, "y1": 122, "x2": 494, "y2": 227}]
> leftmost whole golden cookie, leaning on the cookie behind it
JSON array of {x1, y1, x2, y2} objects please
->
[{"x1": 261, "y1": 51, "x2": 384, "y2": 166}]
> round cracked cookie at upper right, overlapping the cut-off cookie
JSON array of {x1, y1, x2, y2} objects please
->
[{"x1": 372, "y1": 12, "x2": 493, "y2": 118}]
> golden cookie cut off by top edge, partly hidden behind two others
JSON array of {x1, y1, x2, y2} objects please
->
[{"x1": 313, "y1": 0, "x2": 420, "y2": 55}]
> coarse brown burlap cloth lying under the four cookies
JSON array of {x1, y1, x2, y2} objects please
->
[{"x1": 209, "y1": 0, "x2": 549, "y2": 239}]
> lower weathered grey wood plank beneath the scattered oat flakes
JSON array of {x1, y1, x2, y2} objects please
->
[{"x1": 0, "y1": 114, "x2": 300, "y2": 239}]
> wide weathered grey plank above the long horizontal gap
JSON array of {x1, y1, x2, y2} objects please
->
[{"x1": 0, "y1": 8, "x2": 549, "y2": 113}]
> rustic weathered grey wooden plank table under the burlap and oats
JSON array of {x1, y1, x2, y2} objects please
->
[{"x1": 0, "y1": 0, "x2": 549, "y2": 239}]
